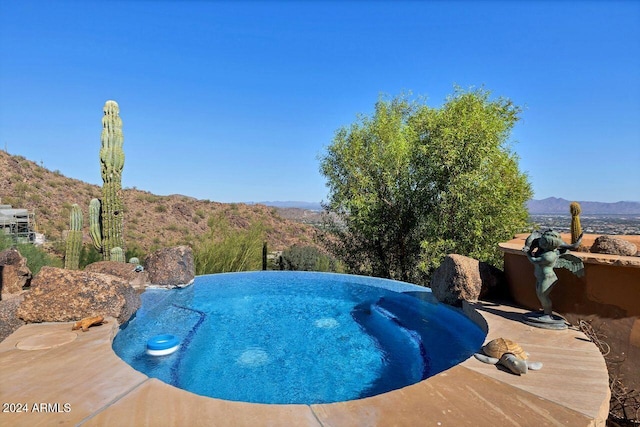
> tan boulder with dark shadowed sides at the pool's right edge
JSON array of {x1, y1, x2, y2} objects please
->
[{"x1": 430, "y1": 254, "x2": 504, "y2": 307}]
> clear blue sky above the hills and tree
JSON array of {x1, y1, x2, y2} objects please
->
[{"x1": 0, "y1": 0, "x2": 640, "y2": 202}]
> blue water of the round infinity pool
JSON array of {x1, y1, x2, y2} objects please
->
[{"x1": 113, "y1": 271, "x2": 485, "y2": 404}]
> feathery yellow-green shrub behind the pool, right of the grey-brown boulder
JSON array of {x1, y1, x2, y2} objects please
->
[{"x1": 194, "y1": 216, "x2": 265, "y2": 275}]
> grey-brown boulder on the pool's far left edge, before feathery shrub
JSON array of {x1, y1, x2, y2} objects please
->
[{"x1": 144, "y1": 246, "x2": 196, "y2": 288}]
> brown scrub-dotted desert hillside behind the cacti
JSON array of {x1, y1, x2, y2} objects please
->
[{"x1": 0, "y1": 150, "x2": 314, "y2": 254}]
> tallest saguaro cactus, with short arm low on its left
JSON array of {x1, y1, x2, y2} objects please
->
[{"x1": 89, "y1": 101, "x2": 124, "y2": 260}]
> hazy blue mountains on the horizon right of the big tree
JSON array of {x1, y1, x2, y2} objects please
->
[{"x1": 527, "y1": 197, "x2": 640, "y2": 215}]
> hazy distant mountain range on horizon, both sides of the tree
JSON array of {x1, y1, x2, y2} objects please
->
[{"x1": 256, "y1": 197, "x2": 640, "y2": 215}]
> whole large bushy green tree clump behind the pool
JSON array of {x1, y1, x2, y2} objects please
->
[{"x1": 321, "y1": 89, "x2": 532, "y2": 282}]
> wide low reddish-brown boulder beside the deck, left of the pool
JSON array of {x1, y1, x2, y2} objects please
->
[{"x1": 18, "y1": 267, "x2": 140, "y2": 323}]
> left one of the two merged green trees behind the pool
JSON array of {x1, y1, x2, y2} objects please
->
[{"x1": 321, "y1": 97, "x2": 422, "y2": 280}]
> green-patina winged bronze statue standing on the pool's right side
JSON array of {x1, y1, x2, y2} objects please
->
[{"x1": 522, "y1": 230, "x2": 584, "y2": 329}]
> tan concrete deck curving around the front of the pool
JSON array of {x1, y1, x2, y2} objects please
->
[{"x1": 0, "y1": 302, "x2": 610, "y2": 427}]
